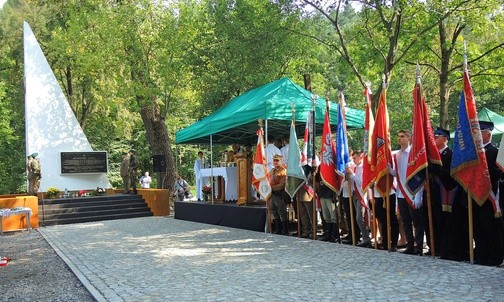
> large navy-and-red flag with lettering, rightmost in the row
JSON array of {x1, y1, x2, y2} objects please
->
[{"x1": 450, "y1": 67, "x2": 492, "y2": 206}]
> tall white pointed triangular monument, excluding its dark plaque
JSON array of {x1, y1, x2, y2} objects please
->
[{"x1": 23, "y1": 22, "x2": 111, "y2": 192}]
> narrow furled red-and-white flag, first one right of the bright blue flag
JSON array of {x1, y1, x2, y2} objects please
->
[{"x1": 362, "y1": 86, "x2": 376, "y2": 192}]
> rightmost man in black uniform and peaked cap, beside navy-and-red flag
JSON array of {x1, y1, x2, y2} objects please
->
[{"x1": 473, "y1": 121, "x2": 502, "y2": 266}]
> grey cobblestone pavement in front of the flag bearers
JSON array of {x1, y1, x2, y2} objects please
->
[{"x1": 40, "y1": 217, "x2": 504, "y2": 301}]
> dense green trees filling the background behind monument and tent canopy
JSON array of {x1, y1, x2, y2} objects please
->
[{"x1": 0, "y1": 0, "x2": 504, "y2": 193}]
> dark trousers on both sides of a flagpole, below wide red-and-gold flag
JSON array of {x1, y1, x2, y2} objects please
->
[{"x1": 375, "y1": 194, "x2": 399, "y2": 249}]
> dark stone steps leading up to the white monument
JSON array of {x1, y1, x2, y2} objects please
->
[{"x1": 39, "y1": 194, "x2": 153, "y2": 226}]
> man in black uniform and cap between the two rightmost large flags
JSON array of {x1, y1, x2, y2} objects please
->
[{"x1": 430, "y1": 128, "x2": 469, "y2": 261}]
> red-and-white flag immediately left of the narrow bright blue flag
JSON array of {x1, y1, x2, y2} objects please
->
[{"x1": 319, "y1": 106, "x2": 341, "y2": 193}]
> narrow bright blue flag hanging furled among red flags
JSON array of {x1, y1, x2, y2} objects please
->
[{"x1": 335, "y1": 93, "x2": 350, "y2": 183}]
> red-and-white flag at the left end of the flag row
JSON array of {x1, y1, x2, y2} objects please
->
[{"x1": 252, "y1": 128, "x2": 271, "y2": 200}]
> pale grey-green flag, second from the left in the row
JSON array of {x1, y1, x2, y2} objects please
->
[{"x1": 285, "y1": 120, "x2": 306, "y2": 198}]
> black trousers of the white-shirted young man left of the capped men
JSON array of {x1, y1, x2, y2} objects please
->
[{"x1": 397, "y1": 198, "x2": 424, "y2": 251}]
